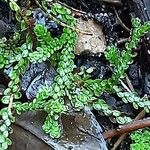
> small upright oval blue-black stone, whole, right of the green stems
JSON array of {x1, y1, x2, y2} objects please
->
[{"x1": 129, "y1": 63, "x2": 140, "y2": 87}]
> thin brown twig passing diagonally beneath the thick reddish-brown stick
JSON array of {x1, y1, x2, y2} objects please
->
[{"x1": 111, "y1": 110, "x2": 145, "y2": 150}]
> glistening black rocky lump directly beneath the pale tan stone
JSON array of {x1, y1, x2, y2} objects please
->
[{"x1": 75, "y1": 56, "x2": 106, "y2": 79}]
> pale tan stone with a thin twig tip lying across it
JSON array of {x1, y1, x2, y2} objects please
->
[{"x1": 75, "y1": 18, "x2": 106, "y2": 54}]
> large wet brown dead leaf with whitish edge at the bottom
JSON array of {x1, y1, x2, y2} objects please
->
[{"x1": 11, "y1": 108, "x2": 107, "y2": 150}]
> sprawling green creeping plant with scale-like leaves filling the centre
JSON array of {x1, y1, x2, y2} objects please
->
[{"x1": 0, "y1": 0, "x2": 150, "y2": 149}]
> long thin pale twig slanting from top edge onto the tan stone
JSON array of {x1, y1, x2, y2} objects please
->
[{"x1": 35, "y1": 0, "x2": 93, "y2": 35}]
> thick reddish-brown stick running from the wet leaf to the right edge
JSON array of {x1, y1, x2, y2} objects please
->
[{"x1": 103, "y1": 118, "x2": 150, "y2": 139}]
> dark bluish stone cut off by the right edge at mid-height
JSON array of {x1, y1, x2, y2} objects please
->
[{"x1": 144, "y1": 74, "x2": 150, "y2": 96}]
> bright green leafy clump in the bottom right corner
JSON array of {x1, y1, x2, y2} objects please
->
[{"x1": 130, "y1": 128, "x2": 150, "y2": 150}]
